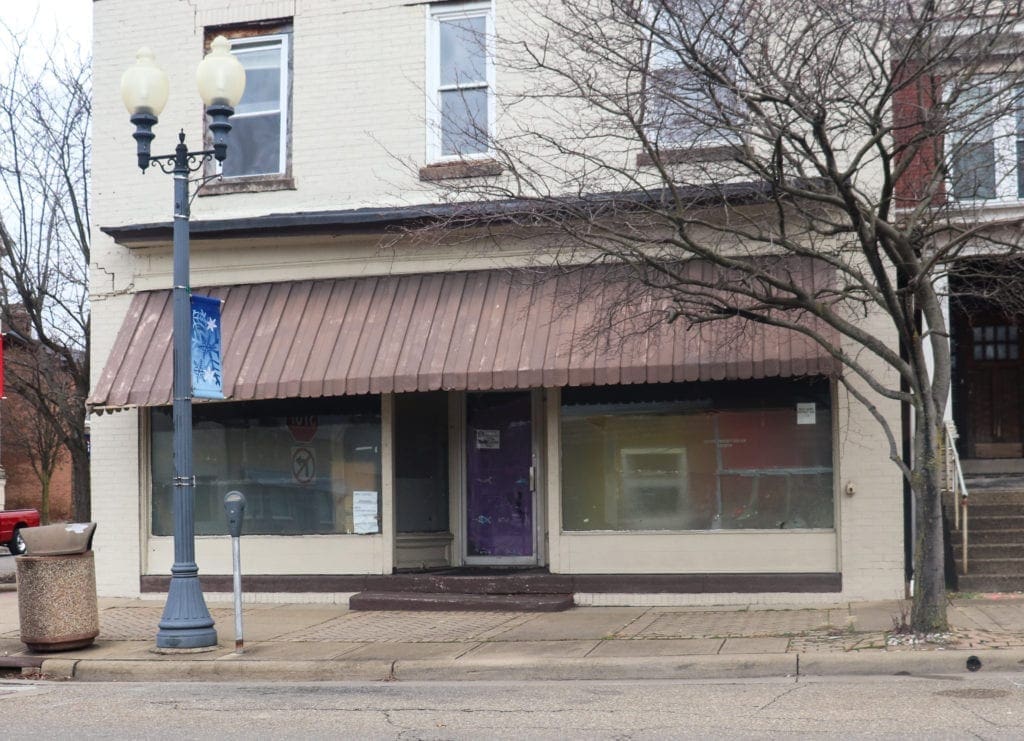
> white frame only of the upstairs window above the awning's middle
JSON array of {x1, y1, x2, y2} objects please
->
[{"x1": 426, "y1": 0, "x2": 496, "y2": 164}]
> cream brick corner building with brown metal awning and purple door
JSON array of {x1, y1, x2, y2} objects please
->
[{"x1": 91, "y1": 0, "x2": 904, "y2": 604}]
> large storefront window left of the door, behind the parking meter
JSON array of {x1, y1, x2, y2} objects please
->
[{"x1": 151, "y1": 396, "x2": 381, "y2": 535}]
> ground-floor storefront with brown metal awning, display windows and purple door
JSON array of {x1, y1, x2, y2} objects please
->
[{"x1": 92, "y1": 264, "x2": 902, "y2": 604}]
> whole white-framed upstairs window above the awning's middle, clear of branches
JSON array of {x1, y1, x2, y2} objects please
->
[{"x1": 427, "y1": 3, "x2": 494, "y2": 162}]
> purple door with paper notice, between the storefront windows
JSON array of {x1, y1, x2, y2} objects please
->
[{"x1": 466, "y1": 392, "x2": 534, "y2": 558}]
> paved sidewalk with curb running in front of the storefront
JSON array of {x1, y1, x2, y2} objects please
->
[{"x1": 0, "y1": 585, "x2": 1024, "y2": 682}]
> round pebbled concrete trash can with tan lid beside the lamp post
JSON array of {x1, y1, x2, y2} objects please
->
[{"x1": 14, "y1": 522, "x2": 99, "y2": 651}]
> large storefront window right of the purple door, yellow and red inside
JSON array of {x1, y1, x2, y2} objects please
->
[{"x1": 561, "y1": 380, "x2": 835, "y2": 530}]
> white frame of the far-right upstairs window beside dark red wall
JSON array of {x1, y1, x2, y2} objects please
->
[{"x1": 945, "y1": 75, "x2": 1024, "y2": 202}]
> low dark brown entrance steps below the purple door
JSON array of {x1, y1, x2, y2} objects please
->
[{"x1": 348, "y1": 568, "x2": 572, "y2": 612}]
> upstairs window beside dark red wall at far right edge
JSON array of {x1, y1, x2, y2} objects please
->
[{"x1": 946, "y1": 78, "x2": 1024, "y2": 201}]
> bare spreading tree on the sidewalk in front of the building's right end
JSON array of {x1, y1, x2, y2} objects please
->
[{"x1": 423, "y1": 0, "x2": 1024, "y2": 631}]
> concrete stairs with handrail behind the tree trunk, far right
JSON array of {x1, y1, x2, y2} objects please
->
[{"x1": 946, "y1": 481, "x2": 1024, "y2": 592}]
